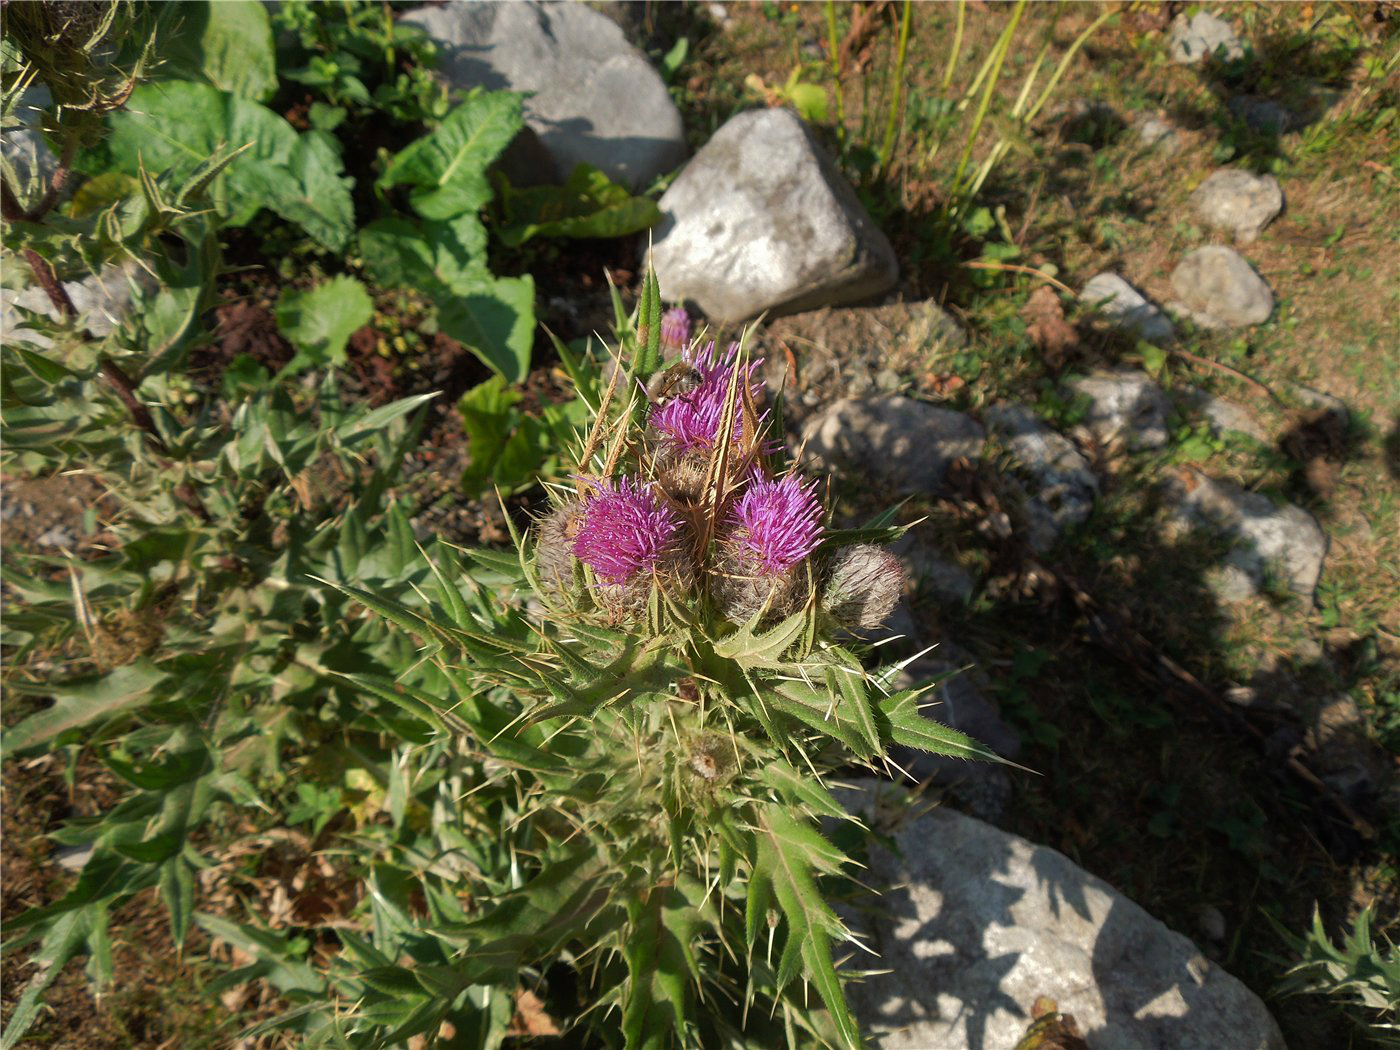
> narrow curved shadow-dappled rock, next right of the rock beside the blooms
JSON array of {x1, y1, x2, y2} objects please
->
[{"x1": 981, "y1": 405, "x2": 1099, "y2": 553}]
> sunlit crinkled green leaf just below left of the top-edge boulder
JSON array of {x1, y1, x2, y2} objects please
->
[{"x1": 379, "y1": 91, "x2": 524, "y2": 218}]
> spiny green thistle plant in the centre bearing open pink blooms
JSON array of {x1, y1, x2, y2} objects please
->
[{"x1": 326, "y1": 277, "x2": 994, "y2": 1047}]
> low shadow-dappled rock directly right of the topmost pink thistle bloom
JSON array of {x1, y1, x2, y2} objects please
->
[{"x1": 802, "y1": 395, "x2": 986, "y2": 493}]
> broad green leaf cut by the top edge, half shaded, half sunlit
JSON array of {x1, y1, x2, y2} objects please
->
[{"x1": 161, "y1": 0, "x2": 277, "y2": 102}]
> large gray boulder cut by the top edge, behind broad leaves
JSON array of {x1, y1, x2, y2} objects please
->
[{"x1": 402, "y1": 0, "x2": 686, "y2": 189}]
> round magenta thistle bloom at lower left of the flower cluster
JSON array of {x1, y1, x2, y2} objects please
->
[{"x1": 574, "y1": 477, "x2": 680, "y2": 585}]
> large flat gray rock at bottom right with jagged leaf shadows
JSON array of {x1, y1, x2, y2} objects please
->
[{"x1": 847, "y1": 785, "x2": 1285, "y2": 1050}]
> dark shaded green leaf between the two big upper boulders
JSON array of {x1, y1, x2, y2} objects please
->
[{"x1": 498, "y1": 164, "x2": 661, "y2": 246}]
